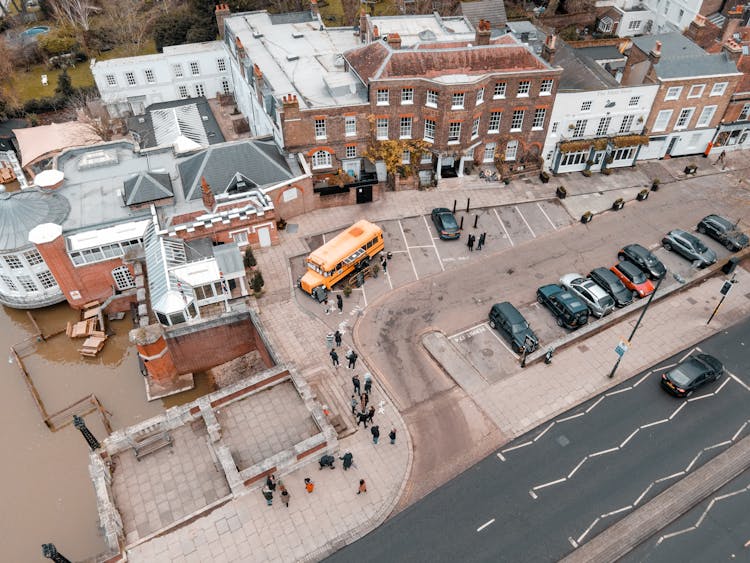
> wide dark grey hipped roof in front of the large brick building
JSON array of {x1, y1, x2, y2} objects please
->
[{"x1": 177, "y1": 139, "x2": 295, "y2": 201}]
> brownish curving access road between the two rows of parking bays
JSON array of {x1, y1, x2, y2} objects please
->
[{"x1": 354, "y1": 172, "x2": 744, "y2": 509}]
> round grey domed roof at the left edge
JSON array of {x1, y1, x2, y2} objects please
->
[{"x1": 0, "y1": 188, "x2": 70, "y2": 250}]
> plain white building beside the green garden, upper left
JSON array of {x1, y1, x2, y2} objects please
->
[{"x1": 91, "y1": 41, "x2": 234, "y2": 117}]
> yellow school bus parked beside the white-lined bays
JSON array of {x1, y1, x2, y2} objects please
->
[{"x1": 299, "y1": 219, "x2": 383, "y2": 301}]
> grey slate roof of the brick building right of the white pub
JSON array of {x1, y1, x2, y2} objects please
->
[{"x1": 633, "y1": 31, "x2": 738, "y2": 78}]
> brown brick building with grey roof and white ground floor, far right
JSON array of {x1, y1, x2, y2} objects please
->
[{"x1": 622, "y1": 33, "x2": 742, "y2": 159}]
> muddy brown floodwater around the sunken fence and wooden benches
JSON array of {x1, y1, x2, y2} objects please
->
[{"x1": 0, "y1": 304, "x2": 203, "y2": 562}]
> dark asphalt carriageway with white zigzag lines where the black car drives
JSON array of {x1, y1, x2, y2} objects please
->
[{"x1": 329, "y1": 320, "x2": 750, "y2": 562}]
